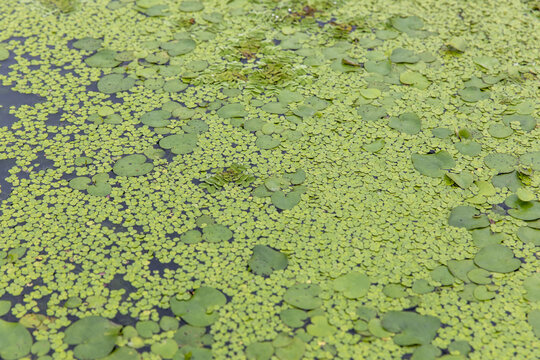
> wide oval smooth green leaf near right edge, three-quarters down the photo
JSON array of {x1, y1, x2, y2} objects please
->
[{"x1": 474, "y1": 244, "x2": 521, "y2": 273}]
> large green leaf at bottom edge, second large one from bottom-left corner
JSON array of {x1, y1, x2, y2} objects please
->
[{"x1": 64, "y1": 316, "x2": 122, "y2": 360}]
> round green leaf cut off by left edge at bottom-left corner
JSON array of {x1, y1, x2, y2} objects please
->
[{"x1": 0, "y1": 319, "x2": 32, "y2": 360}]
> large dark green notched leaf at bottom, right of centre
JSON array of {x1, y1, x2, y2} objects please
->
[{"x1": 381, "y1": 311, "x2": 441, "y2": 346}]
